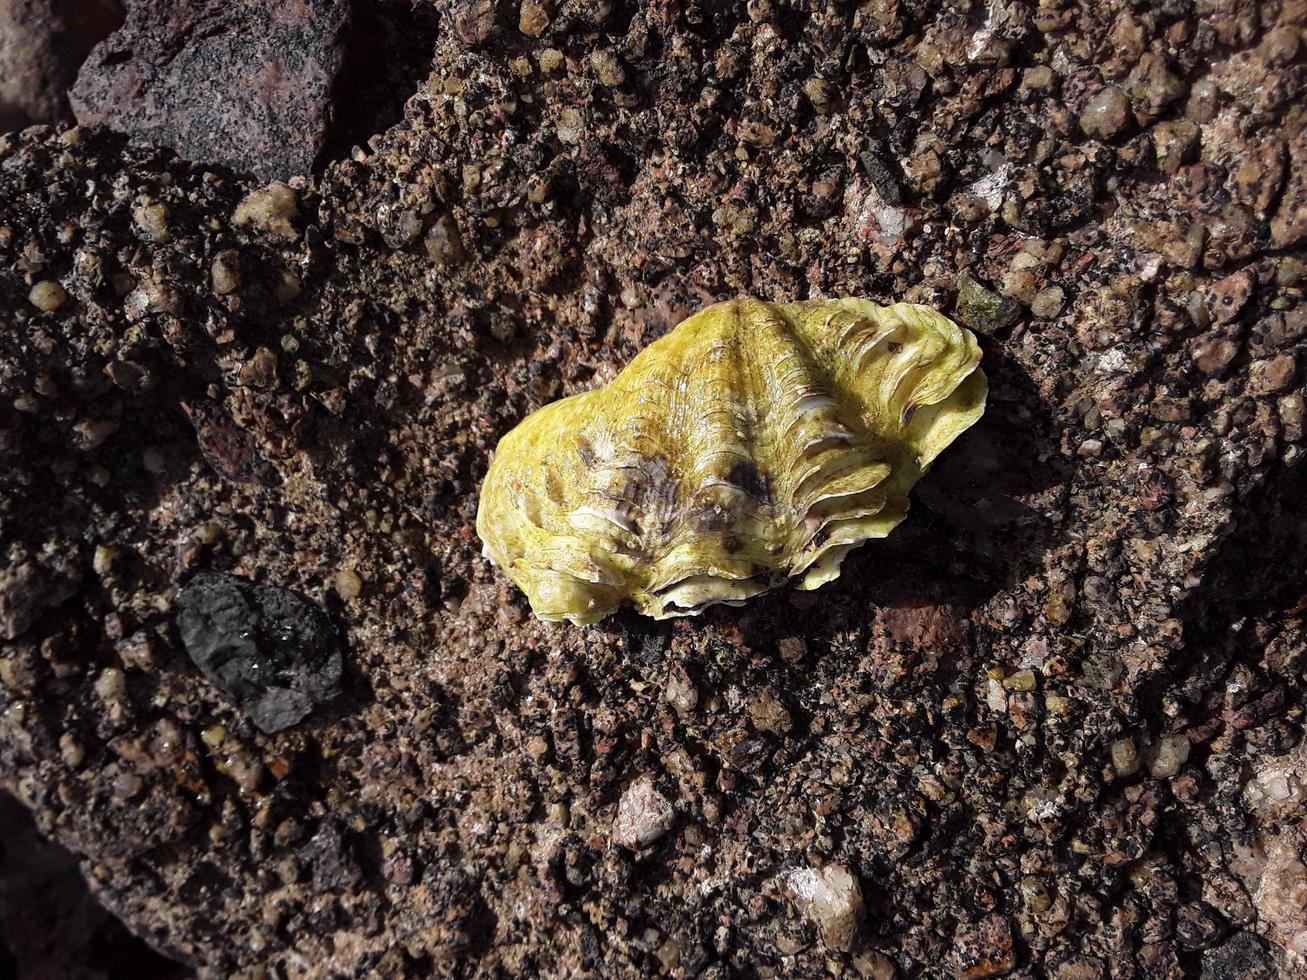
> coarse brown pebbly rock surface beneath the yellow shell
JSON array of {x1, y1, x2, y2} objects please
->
[{"x1": 0, "y1": 0, "x2": 1307, "y2": 980}]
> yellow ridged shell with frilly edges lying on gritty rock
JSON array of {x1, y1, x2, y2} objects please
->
[{"x1": 477, "y1": 299, "x2": 987, "y2": 623}]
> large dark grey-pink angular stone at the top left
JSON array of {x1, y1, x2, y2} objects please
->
[{"x1": 69, "y1": 0, "x2": 349, "y2": 180}]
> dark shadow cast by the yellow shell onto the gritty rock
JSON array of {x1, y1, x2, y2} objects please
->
[{"x1": 612, "y1": 351, "x2": 1074, "y2": 668}]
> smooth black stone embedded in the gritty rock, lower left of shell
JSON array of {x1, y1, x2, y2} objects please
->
[{"x1": 174, "y1": 572, "x2": 342, "y2": 732}]
